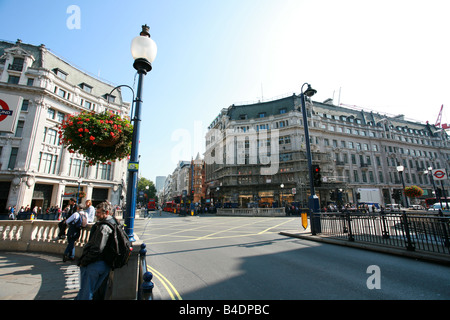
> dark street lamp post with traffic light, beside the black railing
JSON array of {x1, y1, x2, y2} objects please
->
[{"x1": 300, "y1": 83, "x2": 321, "y2": 235}]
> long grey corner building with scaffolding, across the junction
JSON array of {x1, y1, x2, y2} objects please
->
[{"x1": 205, "y1": 94, "x2": 450, "y2": 207}]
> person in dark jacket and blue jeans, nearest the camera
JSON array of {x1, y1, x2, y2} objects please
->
[{"x1": 75, "y1": 202, "x2": 117, "y2": 300}]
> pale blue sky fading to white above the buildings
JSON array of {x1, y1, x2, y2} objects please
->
[{"x1": 0, "y1": 0, "x2": 450, "y2": 181}]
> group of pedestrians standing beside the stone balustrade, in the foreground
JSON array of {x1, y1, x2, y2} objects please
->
[{"x1": 54, "y1": 198, "x2": 118, "y2": 300}]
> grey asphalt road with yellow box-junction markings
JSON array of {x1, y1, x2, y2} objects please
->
[{"x1": 135, "y1": 213, "x2": 450, "y2": 300}]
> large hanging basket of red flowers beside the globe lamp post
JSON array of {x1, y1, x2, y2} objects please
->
[{"x1": 58, "y1": 111, "x2": 133, "y2": 165}]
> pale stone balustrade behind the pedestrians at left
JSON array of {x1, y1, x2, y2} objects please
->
[{"x1": 0, "y1": 220, "x2": 142, "y2": 300}]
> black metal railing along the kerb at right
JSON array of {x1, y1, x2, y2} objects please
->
[{"x1": 316, "y1": 212, "x2": 450, "y2": 254}]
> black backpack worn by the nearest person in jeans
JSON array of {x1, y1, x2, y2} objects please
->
[{"x1": 101, "y1": 218, "x2": 133, "y2": 270}]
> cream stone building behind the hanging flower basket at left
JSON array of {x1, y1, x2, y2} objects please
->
[{"x1": 0, "y1": 40, "x2": 130, "y2": 213}]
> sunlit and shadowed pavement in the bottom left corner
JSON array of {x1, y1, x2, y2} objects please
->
[{"x1": 0, "y1": 251, "x2": 80, "y2": 300}]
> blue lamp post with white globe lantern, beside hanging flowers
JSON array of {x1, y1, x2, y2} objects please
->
[{"x1": 125, "y1": 25, "x2": 157, "y2": 242}]
